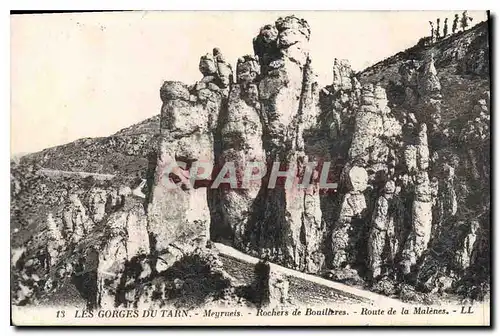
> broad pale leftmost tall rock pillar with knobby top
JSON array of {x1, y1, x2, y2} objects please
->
[{"x1": 148, "y1": 49, "x2": 232, "y2": 253}]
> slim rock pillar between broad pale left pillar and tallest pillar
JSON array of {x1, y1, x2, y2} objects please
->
[{"x1": 219, "y1": 55, "x2": 266, "y2": 248}]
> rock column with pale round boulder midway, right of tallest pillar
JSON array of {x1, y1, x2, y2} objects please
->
[{"x1": 331, "y1": 84, "x2": 402, "y2": 277}]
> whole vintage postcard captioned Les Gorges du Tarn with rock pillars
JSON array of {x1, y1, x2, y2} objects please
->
[{"x1": 10, "y1": 10, "x2": 491, "y2": 326}]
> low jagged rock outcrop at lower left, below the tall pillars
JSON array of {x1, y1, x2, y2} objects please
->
[{"x1": 14, "y1": 182, "x2": 150, "y2": 308}]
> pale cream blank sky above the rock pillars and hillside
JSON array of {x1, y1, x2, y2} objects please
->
[{"x1": 11, "y1": 11, "x2": 486, "y2": 154}]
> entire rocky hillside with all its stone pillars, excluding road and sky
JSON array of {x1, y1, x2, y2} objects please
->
[{"x1": 11, "y1": 16, "x2": 490, "y2": 308}]
